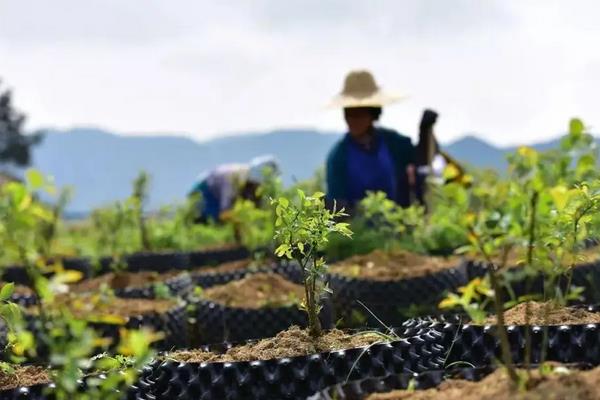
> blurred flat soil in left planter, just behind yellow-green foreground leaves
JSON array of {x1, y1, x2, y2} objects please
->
[{"x1": 28, "y1": 294, "x2": 177, "y2": 322}]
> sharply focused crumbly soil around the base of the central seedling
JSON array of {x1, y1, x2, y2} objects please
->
[{"x1": 168, "y1": 326, "x2": 381, "y2": 363}]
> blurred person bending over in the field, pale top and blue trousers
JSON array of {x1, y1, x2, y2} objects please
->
[{"x1": 189, "y1": 155, "x2": 280, "y2": 222}]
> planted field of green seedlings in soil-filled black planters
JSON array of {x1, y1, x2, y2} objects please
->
[{"x1": 0, "y1": 119, "x2": 600, "y2": 400}]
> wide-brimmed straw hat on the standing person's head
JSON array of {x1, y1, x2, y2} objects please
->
[{"x1": 329, "y1": 70, "x2": 406, "y2": 108}]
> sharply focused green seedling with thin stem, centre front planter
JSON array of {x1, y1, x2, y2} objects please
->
[{"x1": 272, "y1": 190, "x2": 352, "y2": 338}]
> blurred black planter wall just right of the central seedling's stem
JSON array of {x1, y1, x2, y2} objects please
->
[{"x1": 329, "y1": 264, "x2": 467, "y2": 327}]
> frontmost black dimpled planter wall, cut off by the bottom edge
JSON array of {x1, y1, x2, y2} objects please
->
[{"x1": 307, "y1": 367, "x2": 494, "y2": 400}]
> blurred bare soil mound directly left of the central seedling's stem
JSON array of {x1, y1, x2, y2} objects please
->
[{"x1": 202, "y1": 273, "x2": 304, "y2": 309}]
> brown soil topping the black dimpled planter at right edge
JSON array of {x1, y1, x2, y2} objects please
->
[{"x1": 485, "y1": 301, "x2": 600, "y2": 325}]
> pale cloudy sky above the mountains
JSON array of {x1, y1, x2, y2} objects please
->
[{"x1": 0, "y1": 0, "x2": 600, "y2": 145}]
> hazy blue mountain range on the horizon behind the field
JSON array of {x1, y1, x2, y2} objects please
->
[{"x1": 18, "y1": 128, "x2": 584, "y2": 213}]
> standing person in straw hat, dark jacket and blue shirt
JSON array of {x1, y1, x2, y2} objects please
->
[{"x1": 326, "y1": 70, "x2": 415, "y2": 210}]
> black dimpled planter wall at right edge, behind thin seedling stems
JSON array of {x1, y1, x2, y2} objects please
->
[{"x1": 404, "y1": 306, "x2": 600, "y2": 367}]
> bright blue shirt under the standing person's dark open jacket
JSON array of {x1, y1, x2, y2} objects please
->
[{"x1": 346, "y1": 131, "x2": 398, "y2": 206}]
